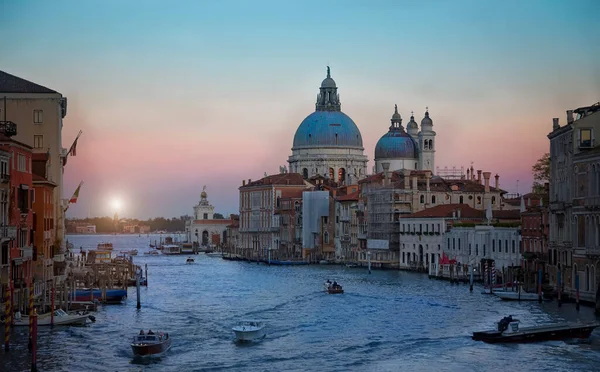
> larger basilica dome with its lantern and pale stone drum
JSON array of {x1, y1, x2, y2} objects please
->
[{"x1": 288, "y1": 67, "x2": 368, "y2": 184}]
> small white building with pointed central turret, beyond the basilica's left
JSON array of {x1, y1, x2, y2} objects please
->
[{"x1": 185, "y1": 186, "x2": 231, "y2": 247}]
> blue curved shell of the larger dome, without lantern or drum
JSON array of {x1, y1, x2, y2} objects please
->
[{"x1": 294, "y1": 111, "x2": 363, "y2": 149}]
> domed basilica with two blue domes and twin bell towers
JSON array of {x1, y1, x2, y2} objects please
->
[{"x1": 288, "y1": 67, "x2": 436, "y2": 185}]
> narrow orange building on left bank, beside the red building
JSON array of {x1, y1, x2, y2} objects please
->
[{"x1": 32, "y1": 154, "x2": 57, "y2": 283}]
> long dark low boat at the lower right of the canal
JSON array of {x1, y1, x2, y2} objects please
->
[{"x1": 472, "y1": 315, "x2": 600, "y2": 343}]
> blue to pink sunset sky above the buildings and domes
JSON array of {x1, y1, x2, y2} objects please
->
[{"x1": 0, "y1": 0, "x2": 600, "y2": 219}]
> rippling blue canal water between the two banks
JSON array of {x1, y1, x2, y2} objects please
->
[{"x1": 0, "y1": 235, "x2": 600, "y2": 372}]
